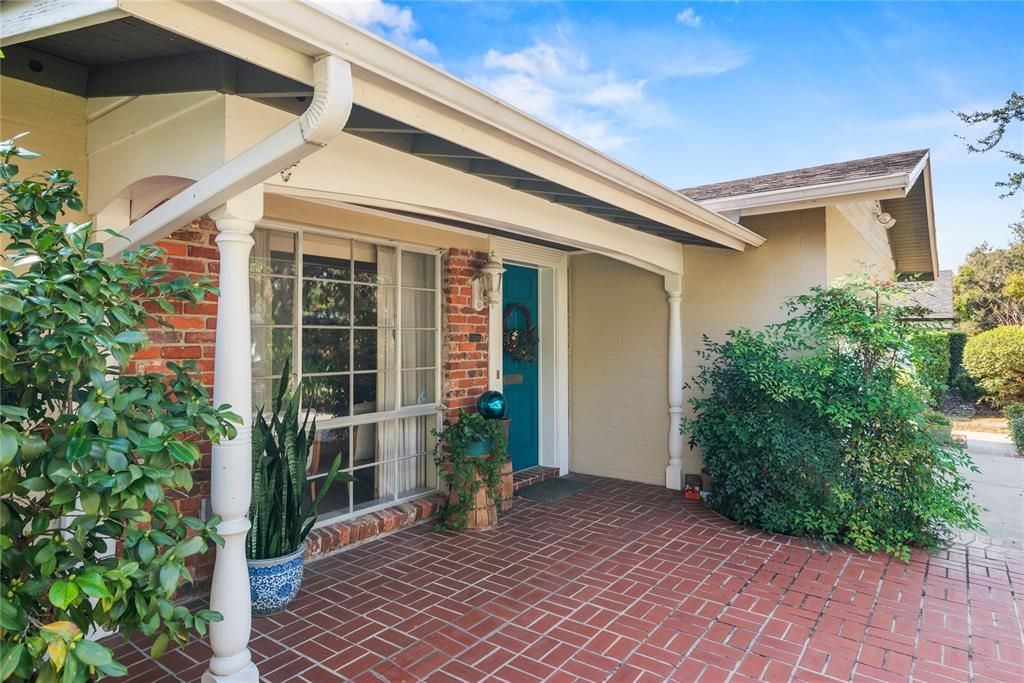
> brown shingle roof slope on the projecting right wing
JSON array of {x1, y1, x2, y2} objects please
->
[{"x1": 679, "y1": 150, "x2": 928, "y2": 202}]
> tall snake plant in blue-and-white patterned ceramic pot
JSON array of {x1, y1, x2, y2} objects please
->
[{"x1": 246, "y1": 362, "x2": 352, "y2": 616}]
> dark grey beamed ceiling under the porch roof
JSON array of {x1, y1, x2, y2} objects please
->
[{"x1": 3, "y1": 16, "x2": 720, "y2": 247}]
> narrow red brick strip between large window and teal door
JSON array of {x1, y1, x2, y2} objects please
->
[{"x1": 441, "y1": 249, "x2": 488, "y2": 420}]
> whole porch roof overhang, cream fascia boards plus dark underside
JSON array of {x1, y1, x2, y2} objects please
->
[{"x1": 0, "y1": 0, "x2": 764, "y2": 270}]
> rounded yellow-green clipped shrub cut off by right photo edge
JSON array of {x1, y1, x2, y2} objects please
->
[{"x1": 964, "y1": 325, "x2": 1024, "y2": 405}]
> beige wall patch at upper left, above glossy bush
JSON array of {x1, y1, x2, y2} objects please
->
[{"x1": 0, "y1": 76, "x2": 89, "y2": 221}]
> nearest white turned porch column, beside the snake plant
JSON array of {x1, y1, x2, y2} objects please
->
[{"x1": 203, "y1": 185, "x2": 263, "y2": 683}]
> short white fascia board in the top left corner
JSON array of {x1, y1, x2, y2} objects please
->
[{"x1": 0, "y1": 0, "x2": 127, "y2": 47}]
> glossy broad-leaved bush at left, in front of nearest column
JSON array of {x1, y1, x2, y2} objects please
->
[{"x1": 0, "y1": 140, "x2": 238, "y2": 683}]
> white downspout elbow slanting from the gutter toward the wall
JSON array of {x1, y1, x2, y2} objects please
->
[{"x1": 104, "y1": 55, "x2": 352, "y2": 257}]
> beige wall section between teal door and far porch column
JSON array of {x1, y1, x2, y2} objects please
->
[{"x1": 569, "y1": 254, "x2": 669, "y2": 484}]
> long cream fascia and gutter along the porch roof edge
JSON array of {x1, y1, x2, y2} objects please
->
[{"x1": 121, "y1": 0, "x2": 764, "y2": 250}]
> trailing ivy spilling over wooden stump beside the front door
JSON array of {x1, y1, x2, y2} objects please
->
[{"x1": 433, "y1": 411, "x2": 509, "y2": 531}]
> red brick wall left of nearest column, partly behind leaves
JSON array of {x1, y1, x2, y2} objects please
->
[{"x1": 127, "y1": 218, "x2": 220, "y2": 592}]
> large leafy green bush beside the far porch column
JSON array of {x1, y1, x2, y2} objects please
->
[{"x1": 682, "y1": 283, "x2": 979, "y2": 558}]
